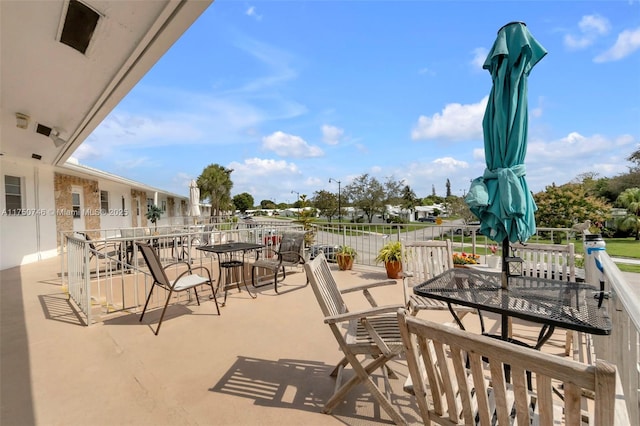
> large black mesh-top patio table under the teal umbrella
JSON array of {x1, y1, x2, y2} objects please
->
[{"x1": 413, "y1": 268, "x2": 611, "y2": 349}]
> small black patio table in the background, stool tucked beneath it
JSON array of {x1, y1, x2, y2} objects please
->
[{"x1": 196, "y1": 242, "x2": 264, "y2": 306}]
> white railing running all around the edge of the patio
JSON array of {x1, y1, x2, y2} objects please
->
[{"x1": 61, "y1": 220, "x2": 640, "y2": 424}]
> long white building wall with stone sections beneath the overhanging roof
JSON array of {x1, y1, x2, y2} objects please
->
[{"x1": 0, "y1": 156, "x2": 186, "y2": 269}]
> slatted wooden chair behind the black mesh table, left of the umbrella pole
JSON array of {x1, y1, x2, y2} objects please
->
[{"x1": 402, "y1": 240, "x2": 474, "y2": 318}]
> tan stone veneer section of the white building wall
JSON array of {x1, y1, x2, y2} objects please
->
[{"x1": 53, "y1": 172, "x2": 100, "y2": 245}]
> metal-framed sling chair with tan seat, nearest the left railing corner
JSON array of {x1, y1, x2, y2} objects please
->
[{"x1": 136, "y1": 242, "x2": 220, "y2": 335}]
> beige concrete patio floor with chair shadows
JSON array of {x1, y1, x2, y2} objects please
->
[{"x1": 0, "y1": 255, "x2": 588, "y2": 426}]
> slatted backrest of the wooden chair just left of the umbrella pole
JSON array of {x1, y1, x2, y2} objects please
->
[{"x1": 402, "y1": 240, "x2": 453, "y2": 300}]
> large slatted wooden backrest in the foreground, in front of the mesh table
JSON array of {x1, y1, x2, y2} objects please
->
[{"x1": 398, "y1": 310, "x2": 616, "y2": 426}]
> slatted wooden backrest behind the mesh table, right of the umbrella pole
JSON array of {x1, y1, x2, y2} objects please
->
[{"x1": 511, "y1": 243, "x2": 576, "y2": 281}]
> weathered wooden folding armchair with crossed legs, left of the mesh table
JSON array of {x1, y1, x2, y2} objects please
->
[{"x1": 304, "y1": 252, "x2": 406, "y2": 424}]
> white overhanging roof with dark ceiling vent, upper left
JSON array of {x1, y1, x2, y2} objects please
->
[{"x1": 0, "y1": 0, "x2": 213, "y2": 165}]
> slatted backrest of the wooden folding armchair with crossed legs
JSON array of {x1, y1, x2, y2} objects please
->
[{"x1": 304, "y1": 252, "x2": 348, "y2": 317}]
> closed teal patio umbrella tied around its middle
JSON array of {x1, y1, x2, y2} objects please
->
[{"x1": 465, "y1": 22, "x2": 547, "y2": 248}]
